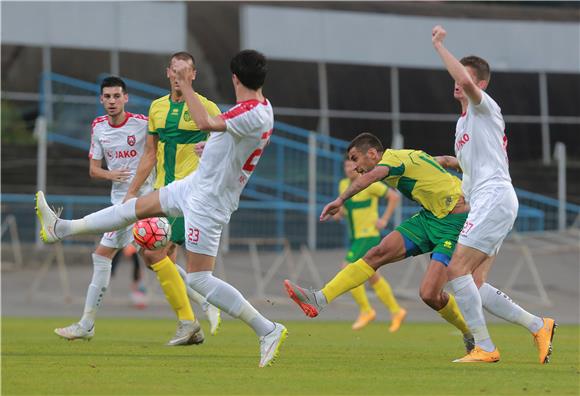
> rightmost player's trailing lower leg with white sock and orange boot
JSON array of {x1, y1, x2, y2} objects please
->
[{"x1": 473, "y1": 256, "x2": 557, "y2": 364}]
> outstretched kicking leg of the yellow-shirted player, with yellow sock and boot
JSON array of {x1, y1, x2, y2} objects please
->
[{"x1": 284, "y1": 231, "x2": 406, "y2": 318}]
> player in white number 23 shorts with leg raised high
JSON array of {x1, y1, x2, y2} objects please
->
[{"x1": 36, "y1": 50, "x2": 288, "y2": 367}]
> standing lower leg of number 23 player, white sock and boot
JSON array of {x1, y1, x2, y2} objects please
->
[{"x1": 187, "y1": 251, "x2": 288, "y2": 367}]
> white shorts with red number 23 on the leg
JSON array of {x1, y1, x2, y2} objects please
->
[{"x1": 159, "y1": 174, "x2": 224, "y2": 257}]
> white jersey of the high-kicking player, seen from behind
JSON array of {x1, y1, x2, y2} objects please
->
[{"x1": 191, "y1": 99, "x2": 274, "y2": 222}]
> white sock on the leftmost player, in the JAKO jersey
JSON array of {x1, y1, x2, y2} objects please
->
[{"x1": 79, "y1": 253, "x2": 111, "y2": 330}]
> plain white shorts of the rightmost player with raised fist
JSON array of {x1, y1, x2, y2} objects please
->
[{"x1": 458, "y1": 186, "x2": 518, "y2": 256}]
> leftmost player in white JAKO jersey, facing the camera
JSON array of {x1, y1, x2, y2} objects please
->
[{"x1": 54, "y1": 77, "x2": 153, "y2": 340}]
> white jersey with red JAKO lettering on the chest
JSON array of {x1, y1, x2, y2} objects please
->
[{"x1": 89, "y1": 113, "x2": 154, "y2": 204}]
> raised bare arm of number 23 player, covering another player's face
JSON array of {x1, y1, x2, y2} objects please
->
[{"x1": 173, "y1": 60, "x2": 226, "y2": 132}]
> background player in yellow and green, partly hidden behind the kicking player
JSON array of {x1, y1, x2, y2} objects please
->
[{"x1": 337, "y1": 158, "x2": 407, "y2": 333}]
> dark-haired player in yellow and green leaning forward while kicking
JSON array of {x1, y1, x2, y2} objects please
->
[{"x1": 284, "y1": 133, "x2": 474, "y2": 351}]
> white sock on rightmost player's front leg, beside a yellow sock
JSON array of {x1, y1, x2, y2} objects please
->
[{"x1": 448, "y1": 274, "x2": 495, "y2": 352}]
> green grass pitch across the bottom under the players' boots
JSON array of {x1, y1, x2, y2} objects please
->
[{"x1": 2, "y1": 318, "x2": 580, "y2": 395}]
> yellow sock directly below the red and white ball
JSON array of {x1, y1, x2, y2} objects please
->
[{"x1": 151, "y1": 257, "x2": 195, "y2": 320}]
